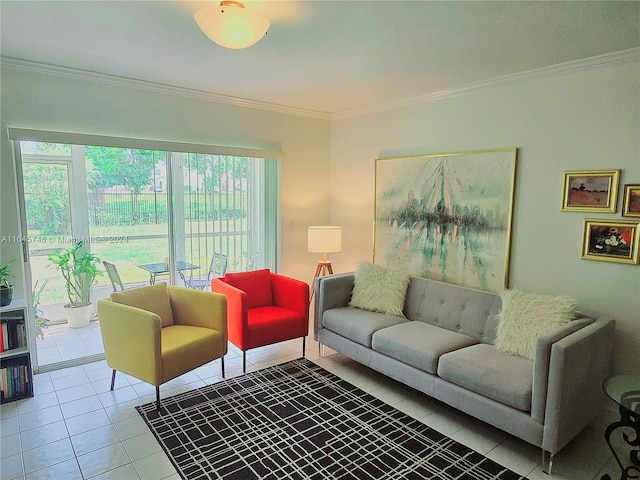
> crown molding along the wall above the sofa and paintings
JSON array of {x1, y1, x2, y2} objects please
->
[{"x1": 330, "y1": 47, "x2": 640, "y2": 120}]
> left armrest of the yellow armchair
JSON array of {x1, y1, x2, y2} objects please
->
[{"x1": 98, "y1": 299, "x2": 162, "y2": 385}]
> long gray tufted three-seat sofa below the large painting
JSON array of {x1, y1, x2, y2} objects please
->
[{"x1": 314, "y1": 273, "x2": 614, "y2": 473}]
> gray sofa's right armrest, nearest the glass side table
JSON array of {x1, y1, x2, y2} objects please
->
[{"x1": 542, "y1": 318, "x2": 615, "y2": 453}]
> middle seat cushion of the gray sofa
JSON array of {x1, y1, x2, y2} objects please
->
[{"x1": 371, "y1": 322, "x2": 478, "y2": 375}]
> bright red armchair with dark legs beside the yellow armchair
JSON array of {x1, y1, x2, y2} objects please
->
[{"x1": 211, "y1": 269, "x2": 309, "y2": 373}]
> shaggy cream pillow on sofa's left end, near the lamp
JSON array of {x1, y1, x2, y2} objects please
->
[{"x1": 349, "y1": 262, "x2": 411, "y2": 317}]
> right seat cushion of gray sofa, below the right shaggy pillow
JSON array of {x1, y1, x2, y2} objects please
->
[{"x1": 438, "y1": 343, "x2": 533, "y2": 412}]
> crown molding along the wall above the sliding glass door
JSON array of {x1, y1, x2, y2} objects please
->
[{"x1": 0, "y1": 56, "x2": 329, "y2": 120}]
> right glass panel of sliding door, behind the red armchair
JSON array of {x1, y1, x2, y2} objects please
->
[{"x1": 179, "y1": 154, "x2": 273, "y2": 283}]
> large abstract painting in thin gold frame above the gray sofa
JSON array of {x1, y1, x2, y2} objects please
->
[{"x1": 373, "y1": 148, "x2": 517, "y2": 292}]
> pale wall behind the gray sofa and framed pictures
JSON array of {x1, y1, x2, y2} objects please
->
[{"x1": 331, "y1": 57, "x2": 640, "y2": 371}]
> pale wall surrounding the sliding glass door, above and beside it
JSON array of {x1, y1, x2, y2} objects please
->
[{"x1": 0, "y1": 66, "x2": 330, "y2": 296}]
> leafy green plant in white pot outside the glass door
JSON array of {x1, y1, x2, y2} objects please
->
[{"x1": 49, "y1": 241, "x2": 102, "y2": 328}]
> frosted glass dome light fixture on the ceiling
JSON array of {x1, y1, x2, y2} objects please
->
[{"x1": 194, "y1": 0, "x2": 270, "y2": 49}]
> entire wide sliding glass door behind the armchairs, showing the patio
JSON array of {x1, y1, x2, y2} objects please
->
[{"x1": 15, "y1": 134, "x2": 279, "y2": 370}]
